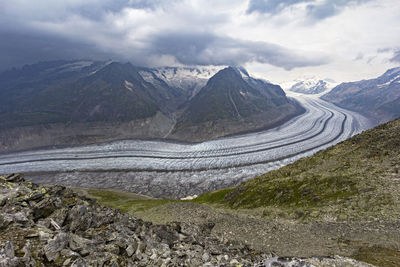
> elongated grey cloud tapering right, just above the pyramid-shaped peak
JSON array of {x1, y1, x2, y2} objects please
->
[{"x1": 150, "y1": 33, "x2": 329, "y2": 70}]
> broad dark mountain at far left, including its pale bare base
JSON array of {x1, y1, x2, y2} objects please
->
[{"x1": 0, "y1": 61, "x2": 185, "y2": 151}]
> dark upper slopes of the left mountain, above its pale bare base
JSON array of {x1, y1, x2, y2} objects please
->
[{"x1": 0, "y1": 62, "x2": 183, "y2": 129}]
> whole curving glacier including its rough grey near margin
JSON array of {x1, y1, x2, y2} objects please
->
[{"x1": 0, "y1": 93, "x2": 371, "y2": 198}]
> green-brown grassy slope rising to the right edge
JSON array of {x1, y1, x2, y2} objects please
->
[{"x1": 196, "y1": 119, "x2": 400, "y2": 220}]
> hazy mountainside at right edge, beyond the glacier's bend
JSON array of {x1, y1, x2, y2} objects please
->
[{"x1": 322, "y1": 67, "x2": 400, "y2": 124}]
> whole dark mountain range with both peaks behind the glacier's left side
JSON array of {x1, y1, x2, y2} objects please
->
[{"x1": 0, "y1": 61, "x2": 303, "y2": 151}]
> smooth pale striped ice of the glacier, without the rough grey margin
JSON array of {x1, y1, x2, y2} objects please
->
[{"x1": 0, "y1": 96, "x2": 368, "y2": 173}]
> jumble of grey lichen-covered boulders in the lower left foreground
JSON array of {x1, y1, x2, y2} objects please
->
[{"x1": 0, "y1": 175, "x2": 371, "y2": 267}]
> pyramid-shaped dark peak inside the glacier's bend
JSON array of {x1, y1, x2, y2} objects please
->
[{"x1": 171, "y1": 67, "x2": 303, "y2": 141}]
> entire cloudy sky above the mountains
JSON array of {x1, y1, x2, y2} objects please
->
[{"x1": 0, "y1": 0, "x2": 400, "y2": 84}]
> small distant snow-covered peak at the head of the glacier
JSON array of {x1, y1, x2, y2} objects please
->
[{"x1": 289, "y1": 78, "x2": 337, "y2": 94}]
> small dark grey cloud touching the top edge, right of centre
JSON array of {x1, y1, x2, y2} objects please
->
[{"x1": 247, "y1": 0, "x2": 372, "y2": 20}]
